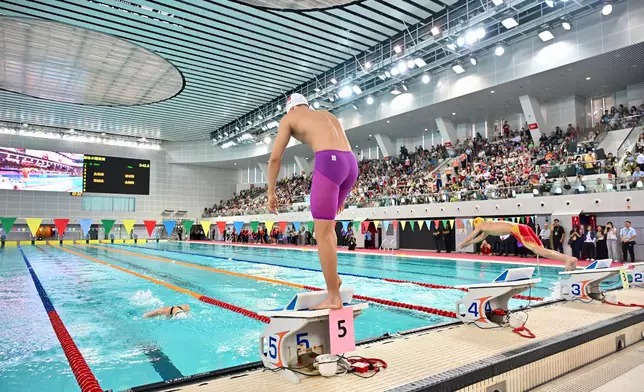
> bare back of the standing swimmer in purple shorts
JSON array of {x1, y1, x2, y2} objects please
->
[{"x1": 282, "y1": 106, "x2": 351, "y2": 152}]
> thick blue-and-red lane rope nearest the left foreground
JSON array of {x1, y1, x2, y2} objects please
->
[{"x1": 18, "y1": 245, "x2": 103, "y2": 392}]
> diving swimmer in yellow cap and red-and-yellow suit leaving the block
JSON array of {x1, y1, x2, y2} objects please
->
[{"x1": 458, "y1": 218, "x2": 577, "y2": 271}]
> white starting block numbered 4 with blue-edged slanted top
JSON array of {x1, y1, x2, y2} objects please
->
[{"x1": 456, "y1": 267, "x2": 541, "y2": 328}]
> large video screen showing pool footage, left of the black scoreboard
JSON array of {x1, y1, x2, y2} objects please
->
[{"x1": 0, "y1": 147, "x2": 83, "y2": 192}]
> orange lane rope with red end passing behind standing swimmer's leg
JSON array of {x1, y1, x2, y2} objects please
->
[{"x1": 78, "y1": 244, "x2": 456, "y2": 318}]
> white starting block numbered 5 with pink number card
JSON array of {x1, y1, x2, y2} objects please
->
[{"x1": 259, "y1": 288, "x2": 368, "y2": 384}]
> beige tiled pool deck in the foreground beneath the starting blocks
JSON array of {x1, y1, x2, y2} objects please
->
[{"x1": 153, "y1": 289, "x2": 644, "y2": 392}]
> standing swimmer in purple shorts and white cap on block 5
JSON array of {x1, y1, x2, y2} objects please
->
[{"x1": 268, "y1": 94, "x2": 358, "y2": 309}]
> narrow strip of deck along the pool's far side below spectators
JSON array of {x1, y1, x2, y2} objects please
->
[{"x1": 182, "y1": 240, "x2": 622, "y2": 268}]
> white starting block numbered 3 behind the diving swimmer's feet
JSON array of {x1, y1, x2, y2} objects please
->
[{"x1": 559, "y1": 259, "x2": 623, "y2": 302}]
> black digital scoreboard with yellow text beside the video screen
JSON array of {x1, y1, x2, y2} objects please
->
[{"x1": 83, "y1": 155, "x2": 150, "y2": 195}]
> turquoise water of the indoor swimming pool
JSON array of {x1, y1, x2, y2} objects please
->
[{"x1": 0, "y1": 242, "x2": 588, "y2": 392}]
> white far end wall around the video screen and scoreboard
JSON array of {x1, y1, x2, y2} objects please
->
[{"x1": 0, "y1": 134, "x2": 237, "y2": 219}]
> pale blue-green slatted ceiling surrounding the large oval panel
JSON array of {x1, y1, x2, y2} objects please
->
[{"x1": 0, "y1": 0, "x2": 458, "y2": 140}]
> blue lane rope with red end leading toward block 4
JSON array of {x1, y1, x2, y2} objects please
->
[{"x1": 108, "y1": 243, "x2": 543, "y2": 301}]
